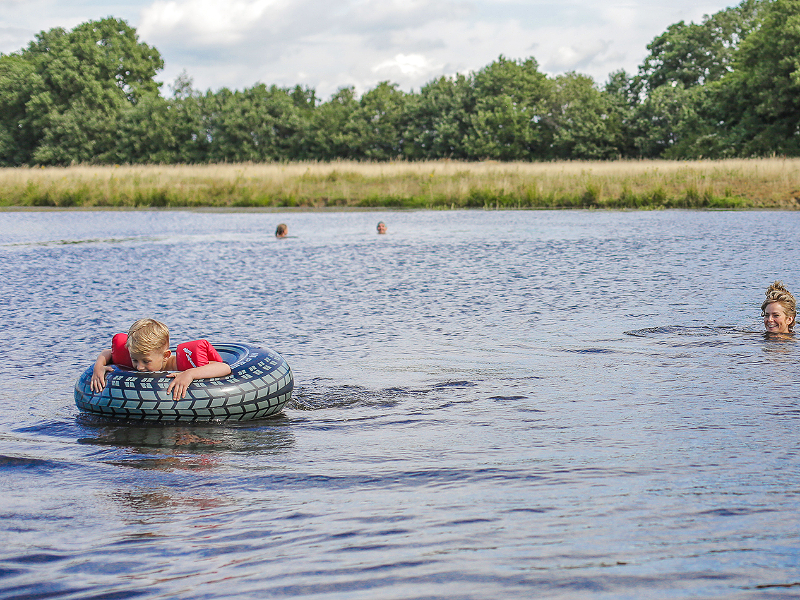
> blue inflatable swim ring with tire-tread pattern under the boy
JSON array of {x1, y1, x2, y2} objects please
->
[{"x1": 75, "y1": 344, "x2": 294, "y2": 421}]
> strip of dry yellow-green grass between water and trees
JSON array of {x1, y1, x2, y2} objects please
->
[{"x1": 0, "y1": 158, "x2": 800, "y2": 209}]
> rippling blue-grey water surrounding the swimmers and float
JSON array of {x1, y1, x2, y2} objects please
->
[{"x1": 0, "y1": 211, "x2": 800, "y2": 599}]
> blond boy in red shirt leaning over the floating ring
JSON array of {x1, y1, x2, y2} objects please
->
[{"x1": 89, "y1": 319, "x2": 231, "y2": 400}]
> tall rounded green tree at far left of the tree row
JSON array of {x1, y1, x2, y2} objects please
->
[{"x1": 0, "y1": 18, "x2": 163, "y2": 164}]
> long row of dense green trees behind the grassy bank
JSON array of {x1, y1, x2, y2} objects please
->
[{"x1": 0, "y1": 0, "x2": 800, "y2": 166}]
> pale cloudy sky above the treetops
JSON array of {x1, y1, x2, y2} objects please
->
[{"x1": 0, "y1": 0, "x2": 737, "y2": 100}]
